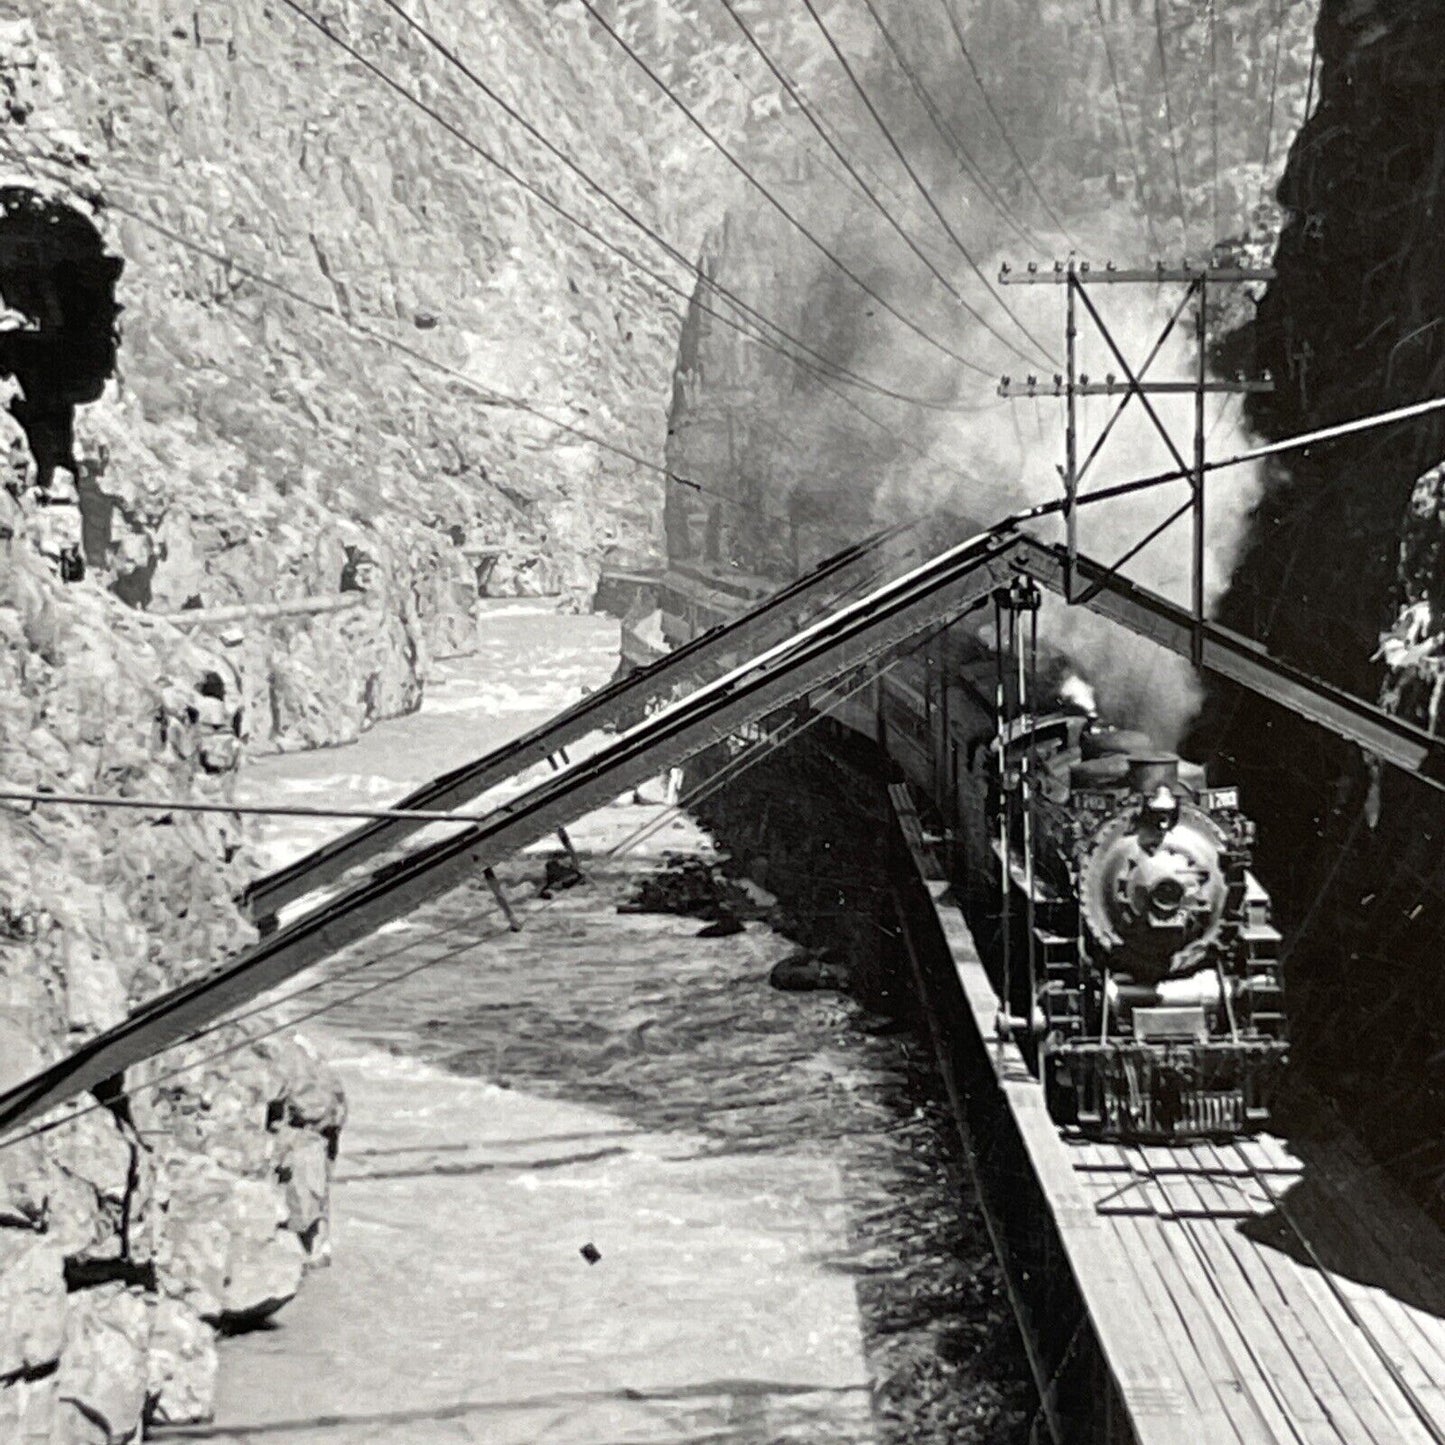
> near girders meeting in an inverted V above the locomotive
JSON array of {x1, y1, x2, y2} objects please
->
[{"x1": 8, "y1": 526, "x2": 1445, "y2": 1131}]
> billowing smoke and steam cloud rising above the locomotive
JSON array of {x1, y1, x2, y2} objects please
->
[{"x1": 669, "y1": 0, "x2": 1277, "y2": 744}]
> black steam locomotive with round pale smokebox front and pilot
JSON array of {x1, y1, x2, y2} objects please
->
[{"x1": 990, "y1": 714, "x2": 1287, "y2": 1140}]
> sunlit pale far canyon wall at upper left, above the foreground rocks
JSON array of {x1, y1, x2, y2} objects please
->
[{"x1": 0, "y1": 0, "x2": 734, "y2": 746}]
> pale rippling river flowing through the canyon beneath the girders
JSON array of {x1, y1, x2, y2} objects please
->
[{"x1": 183, "y1": 604, "x2": 1027, "y2": 1445}]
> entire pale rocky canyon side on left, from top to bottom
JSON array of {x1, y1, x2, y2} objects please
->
[{"x1": 0, "y1": 8, "x2": 745, "y2": 1445}]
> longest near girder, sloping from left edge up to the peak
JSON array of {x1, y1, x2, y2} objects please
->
[{"x1": 0, "y1": 530, "x2": 1017, "y2": 1131}]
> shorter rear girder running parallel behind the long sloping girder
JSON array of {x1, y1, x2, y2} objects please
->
[{"x1": 241, "y1": 527, "x2": 899, "y2": 923}]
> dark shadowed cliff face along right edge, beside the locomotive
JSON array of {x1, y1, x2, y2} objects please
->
[{"x1": 1201, "y1": 0, "x2": 1445, "y2": 1202}]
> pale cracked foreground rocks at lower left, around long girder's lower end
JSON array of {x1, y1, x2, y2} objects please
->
[{"x1": 0, "y1": 401, "x2": 344, "y2": 1445}]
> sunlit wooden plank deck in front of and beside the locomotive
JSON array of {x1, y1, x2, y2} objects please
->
[{"x1": 899, "y1": 838, "x2": 1445, "y2": 1445}]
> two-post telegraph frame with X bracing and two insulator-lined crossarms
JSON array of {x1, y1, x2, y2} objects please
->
[{"x1": 998, "y1": 257, "x2": 1274, "y2": 666}]
